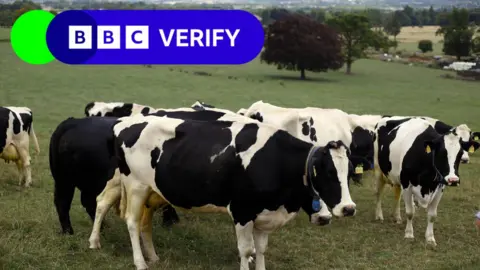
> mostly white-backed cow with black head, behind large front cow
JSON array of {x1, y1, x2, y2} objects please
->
[{"x1": 239, "y1": 100, "x2": 381, "y2": 182}]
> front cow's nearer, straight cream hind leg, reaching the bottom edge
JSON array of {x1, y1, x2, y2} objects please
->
[{"x1": 125, "y1": 180, "x2": 148, "y2": 270}]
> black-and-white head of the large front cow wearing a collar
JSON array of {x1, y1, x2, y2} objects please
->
[{"x1": 304, "y1": 141, "x2": 356, "y2": 217}]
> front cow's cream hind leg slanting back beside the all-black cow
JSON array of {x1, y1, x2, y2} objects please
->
[{"x1": 88, "y1": 180, "x2": 121, "y2": 249}]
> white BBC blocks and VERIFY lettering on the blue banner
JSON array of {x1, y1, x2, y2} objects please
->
[{"x1": 68, "y1": 25, "x2": 240, "y2": 49}]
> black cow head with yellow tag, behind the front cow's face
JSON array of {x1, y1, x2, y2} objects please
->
[{"x1": 350, "y1": 127, "x2": 375, "y2": 183}]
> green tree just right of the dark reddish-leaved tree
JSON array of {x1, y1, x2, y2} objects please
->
[{"x1": 328, "y1": 13, "x2": 374, "y2": 74}]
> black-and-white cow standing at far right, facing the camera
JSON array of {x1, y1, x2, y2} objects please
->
[{"x1": 374, "y1": 117, "x2": 480, "y2": 246}]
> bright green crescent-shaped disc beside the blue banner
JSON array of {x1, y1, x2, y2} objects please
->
[{"x1": 10, "y1": 10, "x2": 55, "y2": 65}]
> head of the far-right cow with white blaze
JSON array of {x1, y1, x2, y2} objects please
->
[{"x1": 424, "y1": 132, "x2": 480, "y2": 186}]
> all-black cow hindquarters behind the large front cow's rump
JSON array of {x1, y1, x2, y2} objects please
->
[{"x1": 49, "y1": 117, "x2": 120, "y2": 234}]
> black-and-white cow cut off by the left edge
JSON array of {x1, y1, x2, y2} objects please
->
[{"x1": 0, "y1": 107, "x2": 40, "y2": 187}]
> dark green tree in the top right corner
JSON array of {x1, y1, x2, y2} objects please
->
[{"x1": 436, "y1": 8, "x2": 475, "y2": 60}]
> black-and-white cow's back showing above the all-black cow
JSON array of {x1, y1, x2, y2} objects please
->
[{"x1": 85, "y1": 101, "x2": 155, "y2": 117}]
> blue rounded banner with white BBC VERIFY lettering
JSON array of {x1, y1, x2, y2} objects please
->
[{"x1": 47, "y1": 10, "x2": 264, "y2": 65}]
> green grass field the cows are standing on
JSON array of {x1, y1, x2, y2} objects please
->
[{"x1": 0, "y1": 43, "x2": 480, "y2": 270}]
